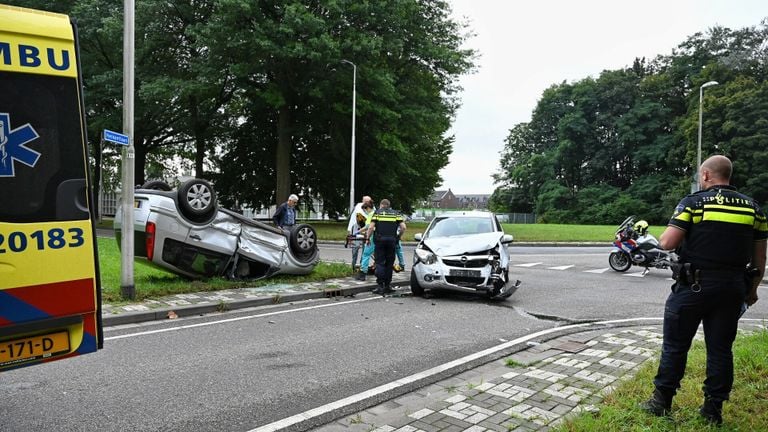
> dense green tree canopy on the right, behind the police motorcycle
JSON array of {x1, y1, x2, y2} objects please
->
[{"x1": 491, "y1": 20, "x2": 768, "y2": 224}]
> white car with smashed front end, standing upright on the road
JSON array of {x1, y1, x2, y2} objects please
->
[{"x1": 411, "y1": 211, "x2": 520, "y2": 300}]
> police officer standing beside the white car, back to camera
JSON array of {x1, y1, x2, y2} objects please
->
[{"x1": 365, "y1": 199, "x2": 405, "y2": 294}]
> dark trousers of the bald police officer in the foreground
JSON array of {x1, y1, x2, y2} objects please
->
[{"x1": 653, "y1": 270, "x2": 747, "y2": 401}]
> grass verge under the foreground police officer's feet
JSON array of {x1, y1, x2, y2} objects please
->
[{"x1": 551, "y1": 330, "x2": 768, "y2": 432}]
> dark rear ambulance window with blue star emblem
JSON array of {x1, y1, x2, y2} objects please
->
[{"x1": 0, "y1": 72, "x2": 87, "y2": 222}]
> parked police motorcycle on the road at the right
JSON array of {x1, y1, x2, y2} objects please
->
[{"x1": 608, "y1": 216, "x2": 678, "y2": 275}]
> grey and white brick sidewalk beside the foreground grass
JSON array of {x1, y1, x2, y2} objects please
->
[{"x1": 314, "y1": 324, "x2": 768, "y2": 432}]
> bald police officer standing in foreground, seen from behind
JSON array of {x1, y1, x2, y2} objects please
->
[{"x1": 641, "y1": 156, "x2": 768, "y2": 425}]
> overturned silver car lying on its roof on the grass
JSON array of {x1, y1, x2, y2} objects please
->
[{"x1": 114, "y1": 179, "x2": 319, "y2": 279}]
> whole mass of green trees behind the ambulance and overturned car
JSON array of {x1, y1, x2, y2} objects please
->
[{"x1": 9, "y1": 0, "x2": 474, "y2": 216}]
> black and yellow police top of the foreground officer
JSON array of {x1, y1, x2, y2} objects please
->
[{"x1": 669, "y1": 186, "x2": 768, "y2": 271}]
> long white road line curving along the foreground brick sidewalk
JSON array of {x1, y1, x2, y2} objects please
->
[{"x1": 248, "y1": 318, "x2": 662, "y2": 432}]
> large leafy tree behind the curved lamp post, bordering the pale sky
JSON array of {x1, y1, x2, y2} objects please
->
[{"x1": 210, "y1": 0, "x2": 472, "y2": 215}]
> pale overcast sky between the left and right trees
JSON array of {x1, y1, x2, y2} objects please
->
[{"x1": 440, "y1": 0, "x2": 768, "y2": 194}]
